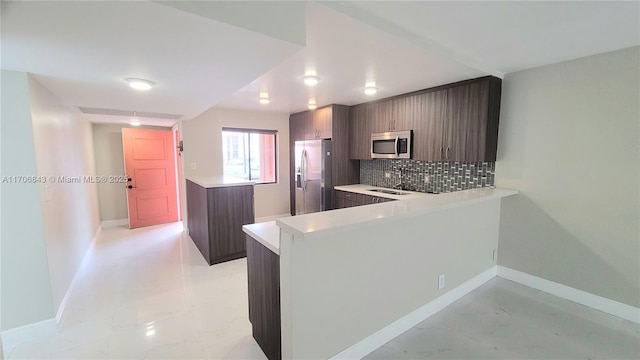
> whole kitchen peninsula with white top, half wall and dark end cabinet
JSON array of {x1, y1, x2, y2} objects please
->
[{"x1": 243, "y1": 188, "x2": 517, "y2": 359}]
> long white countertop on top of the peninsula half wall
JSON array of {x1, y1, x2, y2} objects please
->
[{"x1": 276, "y1": 188, "x2": 518, "y2": 238}]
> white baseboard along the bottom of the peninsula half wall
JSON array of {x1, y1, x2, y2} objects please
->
[{"x1": 331, "y1": 266, "x2": 496, "y2": 360}]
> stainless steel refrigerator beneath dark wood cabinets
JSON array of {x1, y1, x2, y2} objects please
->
[{"x1": 295, "y1": 140, "x2": 333, "y2": 215}]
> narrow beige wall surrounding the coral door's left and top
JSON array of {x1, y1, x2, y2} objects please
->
[{"x1": 93, "y1": 124, "x2": 169, "y2": 221}]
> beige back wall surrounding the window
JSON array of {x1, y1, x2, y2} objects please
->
[{"x1": 182, "y1": 107, "x2": 289, "y2": 218}]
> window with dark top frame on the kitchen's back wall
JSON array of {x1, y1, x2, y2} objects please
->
[{"x1": 222, "y1": 128, "x2": 277, "y2": 184}]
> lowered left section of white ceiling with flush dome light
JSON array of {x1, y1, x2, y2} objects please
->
[{"x1": 1, "y1": 0, "x2": 303, "y2": 123}]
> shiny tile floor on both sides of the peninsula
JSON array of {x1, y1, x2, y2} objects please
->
[{"x1": 4, "y1": 223, "x2": 640, "y2": 359}]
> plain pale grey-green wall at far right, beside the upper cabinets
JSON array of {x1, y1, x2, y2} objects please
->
[{"x1": 496, "y1": 47, "x2": 640, "y2": 307}]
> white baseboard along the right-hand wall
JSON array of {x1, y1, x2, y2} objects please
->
[{"x1": 498, "y1": 266, "x2": 640, "y2": 324}]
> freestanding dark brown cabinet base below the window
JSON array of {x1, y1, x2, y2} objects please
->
[{"x1": 187, "y1": 180, "x2": 255, "y2": 265}]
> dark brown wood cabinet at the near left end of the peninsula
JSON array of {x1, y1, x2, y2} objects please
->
[{"x1": 246, "y1": 235, "x2": 282, "y2": 360}]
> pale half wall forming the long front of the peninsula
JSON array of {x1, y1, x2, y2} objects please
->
[{"x1": 280, "y1": 199, "x2": 500, "y2": 359}]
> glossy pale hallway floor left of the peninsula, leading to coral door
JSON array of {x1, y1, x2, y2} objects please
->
[{"x1": 5, "y1": 223, "x2": 265, "y2": 359}]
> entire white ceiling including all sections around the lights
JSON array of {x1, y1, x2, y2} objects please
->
[{"x1": 1, "y1": 0, "x2": 640, "y2": 125}]
